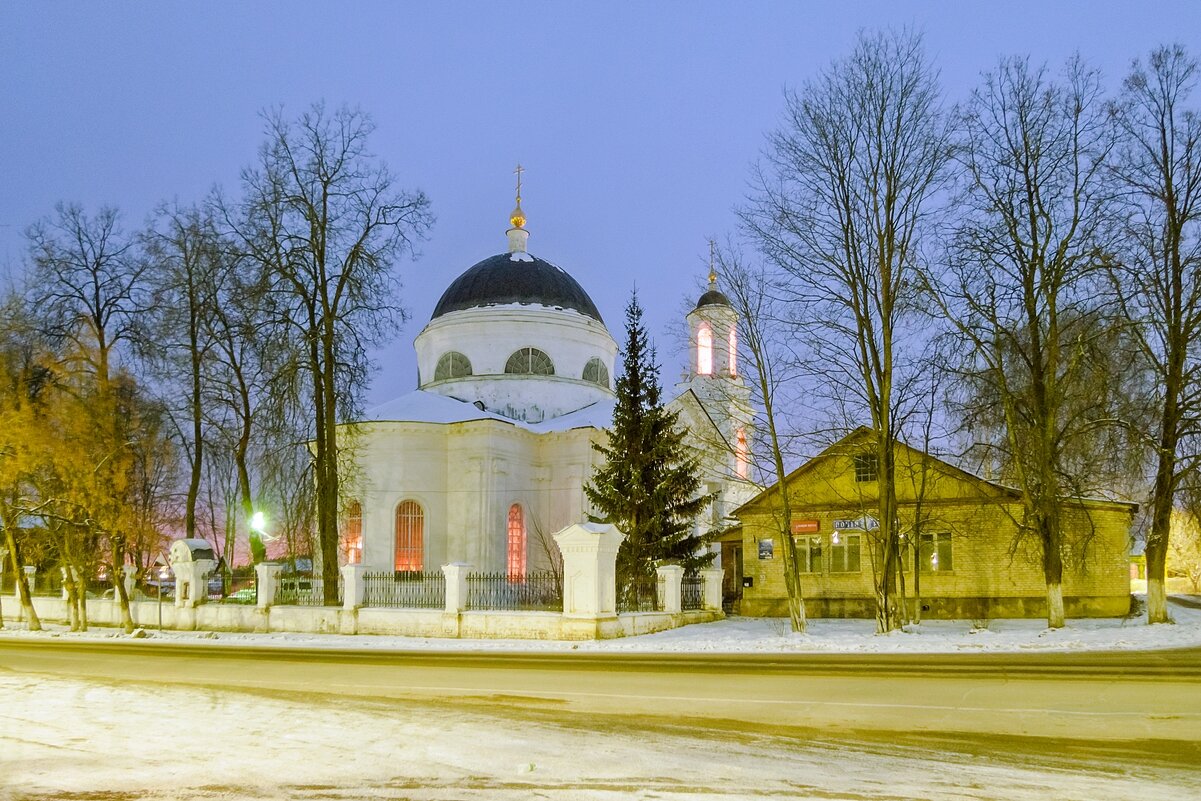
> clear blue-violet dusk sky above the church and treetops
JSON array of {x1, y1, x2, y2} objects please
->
[{"x1": 0, "y1": 0, "x2": 1201, "y2": 402}]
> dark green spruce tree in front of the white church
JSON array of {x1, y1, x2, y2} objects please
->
[{"x1": 584, "y1": 292, "x2": 713, "y2": 587}]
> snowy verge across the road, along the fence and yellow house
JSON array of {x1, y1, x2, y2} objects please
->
[{"x1": 0, "y1": 595, "x2": 1201, "y2": 653}]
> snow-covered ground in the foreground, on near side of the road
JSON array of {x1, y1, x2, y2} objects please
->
[{"x1": 0, "y1": 666, "x2": 1201, "y2": 801}]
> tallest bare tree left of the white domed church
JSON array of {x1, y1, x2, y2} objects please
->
[{"x1": 229, "y1": 104, "x2": 431, "y2": 598}]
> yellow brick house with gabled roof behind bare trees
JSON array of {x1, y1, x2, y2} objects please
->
[{"x1": 722, "y1": 429, "x2": 1137, "y2": 618}]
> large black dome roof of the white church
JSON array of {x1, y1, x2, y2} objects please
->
[{"x1": 430, "y1": 253, "x2": 604, "y2": 325}]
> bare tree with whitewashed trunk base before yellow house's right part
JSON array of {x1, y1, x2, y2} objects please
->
[{"x1": 928, "y1": 58, "x2": 1118, "y2": 627}]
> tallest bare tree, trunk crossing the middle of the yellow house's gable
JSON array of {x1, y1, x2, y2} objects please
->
[{"x1": 742, "y1": 31, "x2": 950, "y2": 632}]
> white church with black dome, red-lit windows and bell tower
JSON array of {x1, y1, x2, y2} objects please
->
[{"x1": 342, "y1": 184, "x2": 753, "y2": 576}]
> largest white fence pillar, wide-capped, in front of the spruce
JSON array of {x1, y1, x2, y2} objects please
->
[{"x1": 555, "y1": 522, "x2": 626, "y2": 618}]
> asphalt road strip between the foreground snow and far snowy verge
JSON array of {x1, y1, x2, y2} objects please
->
[{"x1": 0, "y1": 638, "x2": 1201, "y2": 760}]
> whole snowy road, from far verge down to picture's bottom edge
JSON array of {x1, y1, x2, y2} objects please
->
[{"x1": 0, "y1": 641, "x2": 1201, "y2": 801}]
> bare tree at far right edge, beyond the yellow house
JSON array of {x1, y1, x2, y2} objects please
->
[{"x1": 1110, "y1": 44, "x2": 1201, "y2": 623}]
